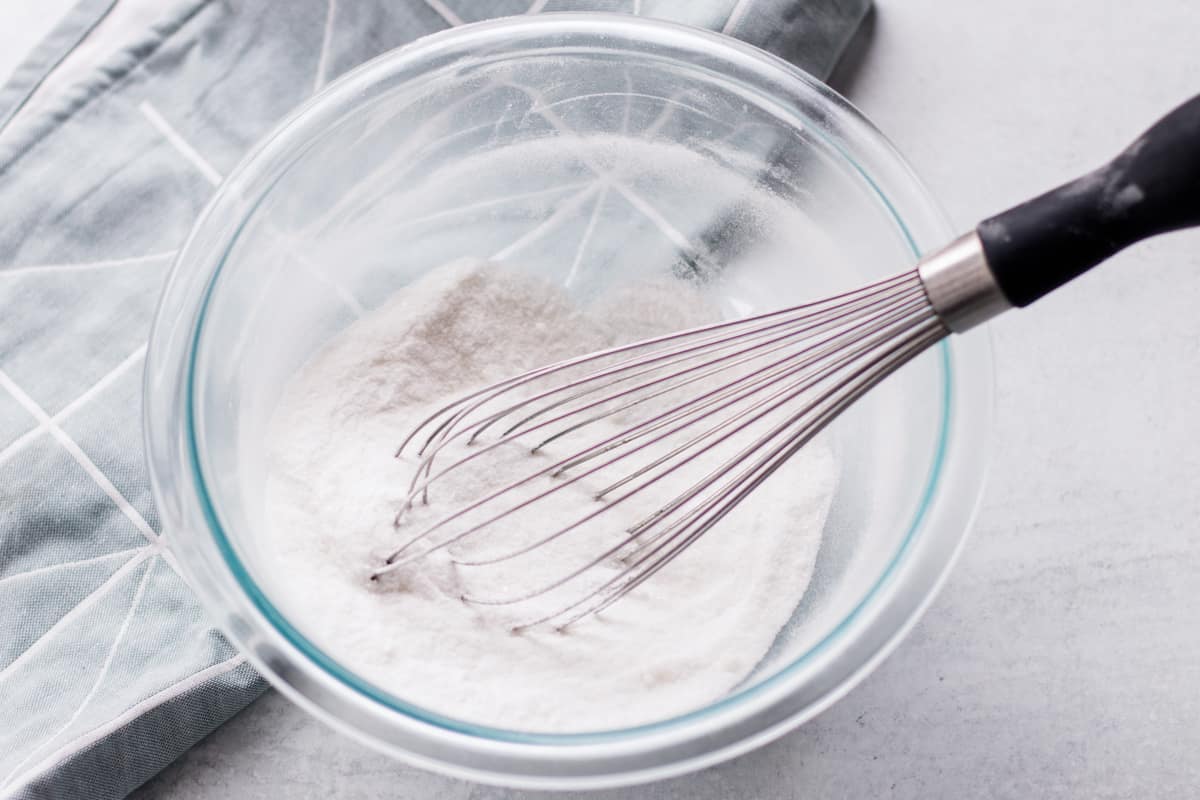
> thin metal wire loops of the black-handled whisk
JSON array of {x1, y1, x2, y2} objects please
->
[{"x1": 372, "y1": 271, "x2": 947, "y2": 630}]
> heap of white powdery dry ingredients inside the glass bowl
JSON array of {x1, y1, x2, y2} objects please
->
[{"x1": 266, "y1": 257, "x2": 836, "y2": 732}]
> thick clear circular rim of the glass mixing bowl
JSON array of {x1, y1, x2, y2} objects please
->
[{"x1": 144, "y1": 13, "x2": 991, "y2": 788}]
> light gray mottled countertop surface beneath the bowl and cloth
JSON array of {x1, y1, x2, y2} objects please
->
[{"x1": 14, "y1": 0, "x2": 1200, "y2": 800}]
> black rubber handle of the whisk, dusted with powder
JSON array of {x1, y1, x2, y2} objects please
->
[{"x1": 976, "y1": 96, "x2": 1200, "y2": 306}]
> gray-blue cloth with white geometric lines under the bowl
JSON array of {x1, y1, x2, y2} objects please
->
[{"x1": 0, "y1": 0, "x2": 870, "y2": 800}]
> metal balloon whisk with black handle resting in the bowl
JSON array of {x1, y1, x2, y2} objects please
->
[{"x1": 372, "y1": 96, "x2": 1200, "y2": 630}]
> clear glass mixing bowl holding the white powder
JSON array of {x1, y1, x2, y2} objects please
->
[{"x1": 145, "y1": 14, "x2": 991, "y2": 787}]
